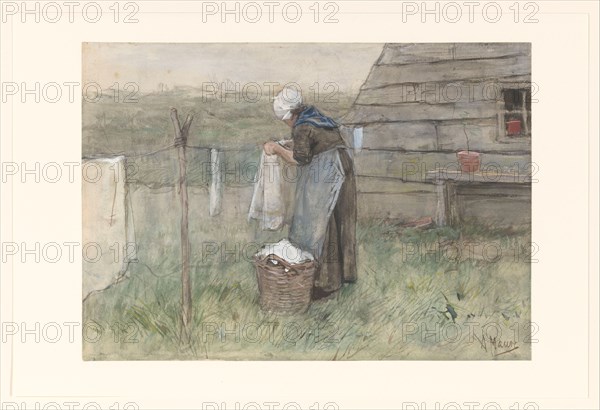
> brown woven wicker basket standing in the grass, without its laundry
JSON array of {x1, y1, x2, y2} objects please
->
[{"x1": 254, "y1": 255, "x2": 317, "y2": 314}]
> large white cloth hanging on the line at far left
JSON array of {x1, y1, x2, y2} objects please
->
[{"x1": 82, "y1": 156, "x2": 137, "y2": 299}]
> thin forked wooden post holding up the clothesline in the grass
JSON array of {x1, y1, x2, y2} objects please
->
[{"x1": 171, "y1": 108, "x2": 193, "y2": 344}]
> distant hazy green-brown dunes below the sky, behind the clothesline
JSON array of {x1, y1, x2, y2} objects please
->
[{"x1": 82, "y1": 89, "x2": 355, "y2": 157}]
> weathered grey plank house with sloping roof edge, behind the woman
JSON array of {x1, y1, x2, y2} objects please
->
[{"x1": 343, "y1": 43, "x2": 535, "y2": 226}]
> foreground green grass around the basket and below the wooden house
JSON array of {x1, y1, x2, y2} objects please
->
[{"x1": 84, "y1": 205, "x2": 531, "y2": 360}]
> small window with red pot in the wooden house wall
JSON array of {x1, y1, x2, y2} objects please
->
[{"x1": 499, "y1": 88, "x2": 531, "y2": 138}]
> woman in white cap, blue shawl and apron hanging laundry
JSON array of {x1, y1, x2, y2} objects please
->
[{"x1": 264, "y1": 88, "x2": 357, "y2": 299}]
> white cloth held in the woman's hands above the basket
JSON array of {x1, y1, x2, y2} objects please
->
[{"x1": 248, "y1": 151, "x2": 291, "y2": 230}]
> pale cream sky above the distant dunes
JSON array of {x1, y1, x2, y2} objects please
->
[{"x1": 83, "y1": 43, "x2": 383, "y2": 93}]
